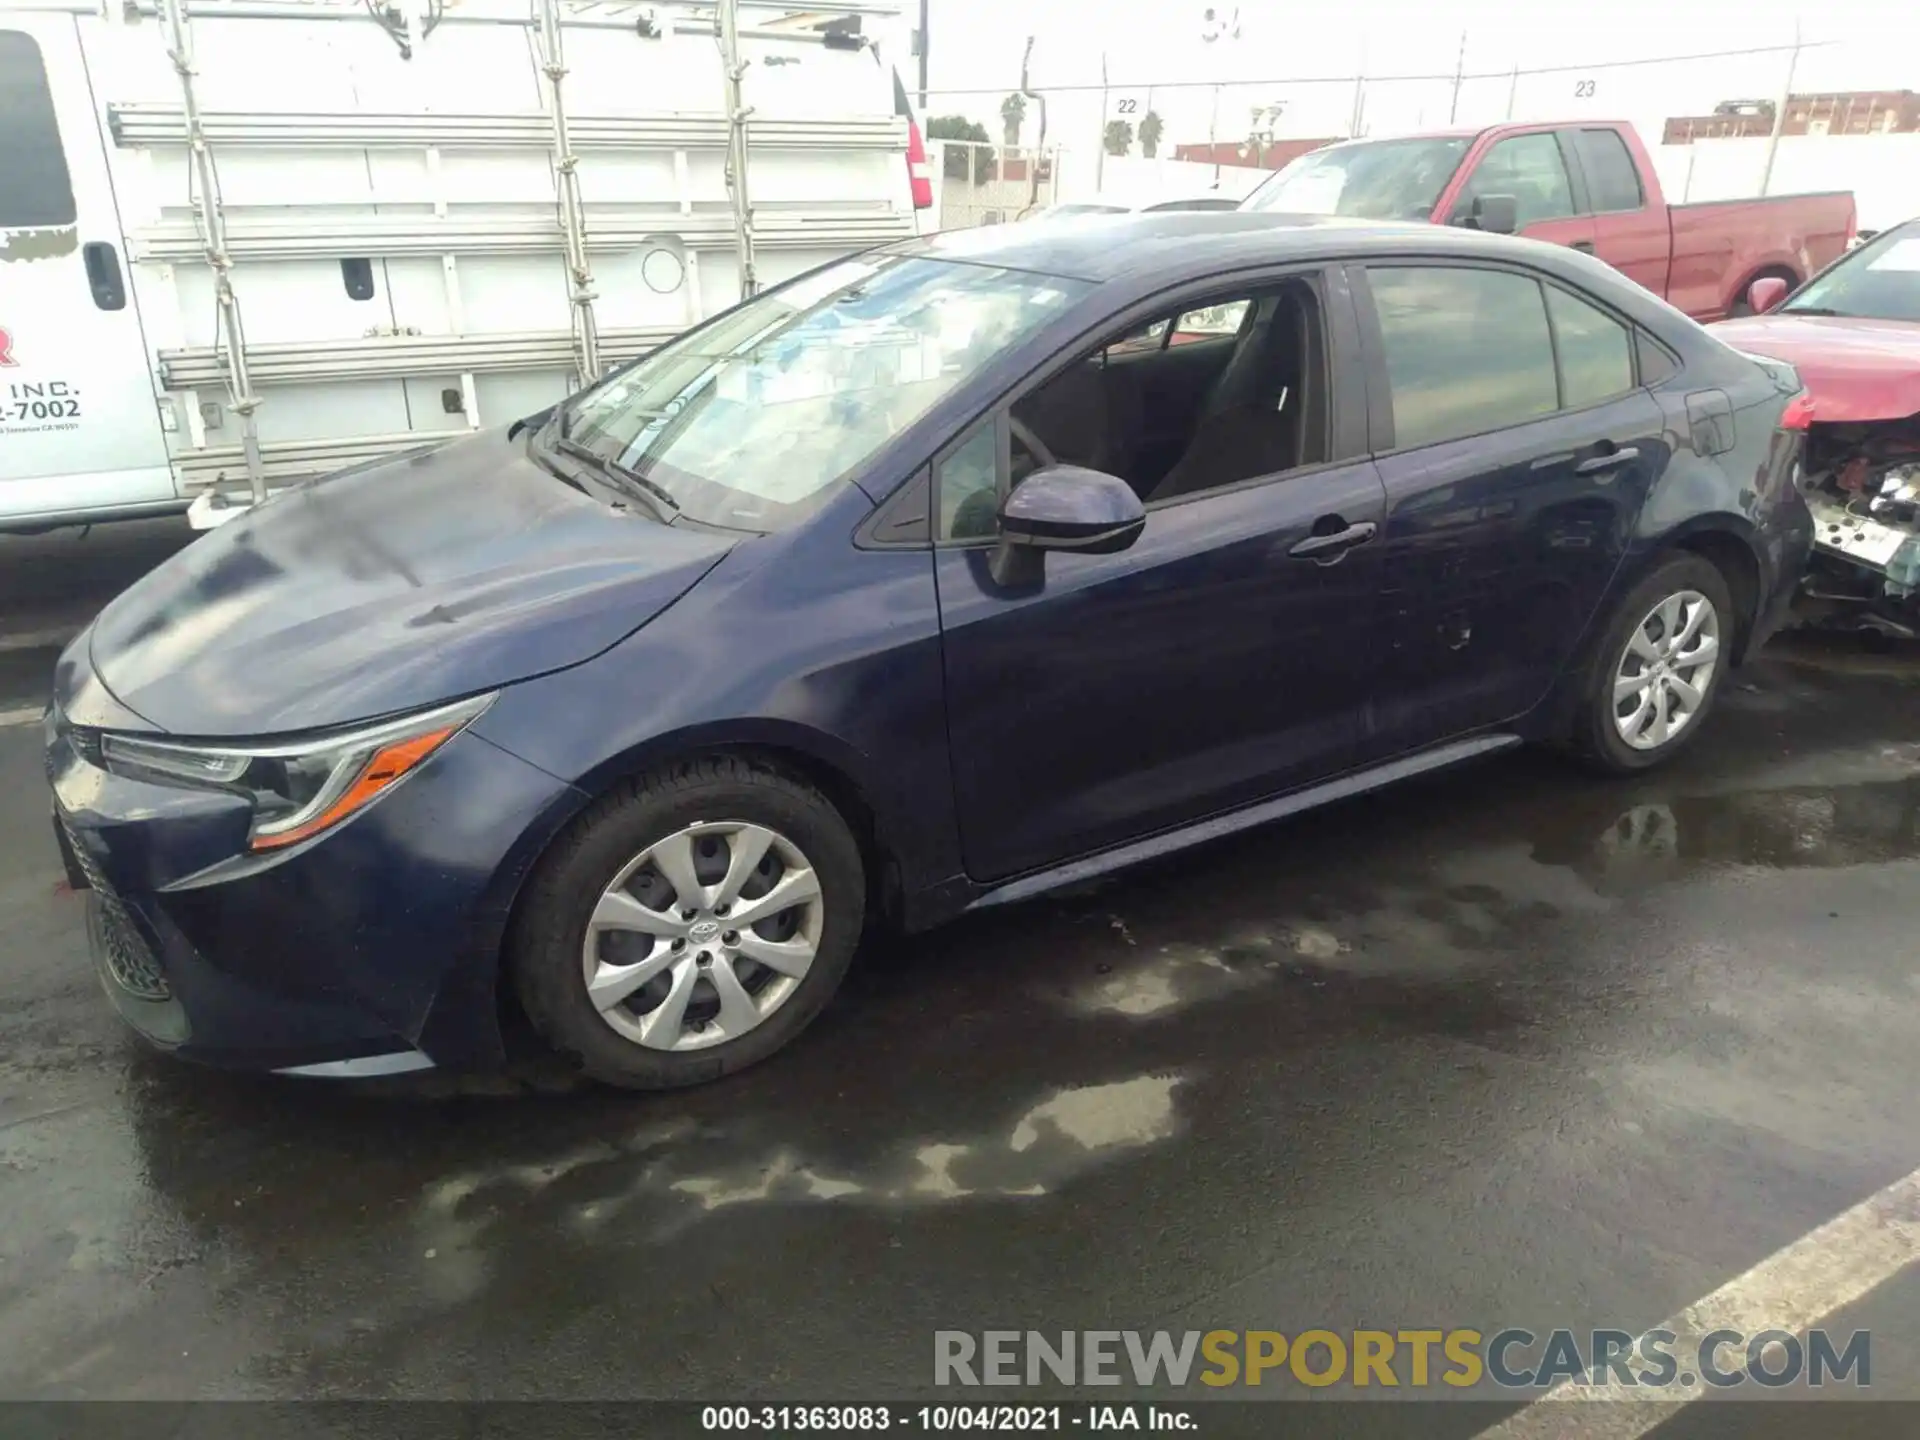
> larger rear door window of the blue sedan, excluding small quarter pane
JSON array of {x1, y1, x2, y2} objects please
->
[{"x1": 1367, "y1": 265, "x2": 1559, "y2": 449}]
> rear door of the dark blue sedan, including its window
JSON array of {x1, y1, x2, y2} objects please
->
[{"x1": 1356, "y1": 261, "x2": 1668, "y2": 760}]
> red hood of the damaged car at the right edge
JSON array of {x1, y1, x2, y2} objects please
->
[{"x1": 1713, "y1": 313, "x2": 1920, "y2": 422}]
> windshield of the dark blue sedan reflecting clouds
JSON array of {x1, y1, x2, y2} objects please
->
[{"x1": 564, "y1": 255, "x2": 1089, "y2": 532}]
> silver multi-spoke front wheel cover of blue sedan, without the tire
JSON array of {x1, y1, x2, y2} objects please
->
[{"x1": 582, "y1": 820, "x2": 826, "y2": 1050}]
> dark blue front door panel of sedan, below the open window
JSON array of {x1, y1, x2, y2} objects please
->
[{"x1": 935, "y1": 424, "x2": 1380, "y2": 881}]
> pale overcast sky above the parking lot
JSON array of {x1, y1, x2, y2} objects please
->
[{"x1": 900, "y1": 0, "x2": 1920, "y2": 154}]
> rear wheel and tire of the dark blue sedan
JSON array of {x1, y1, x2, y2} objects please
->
[{"x1": 1569, "y1": 555, "x2": 1740, "y2": 776}]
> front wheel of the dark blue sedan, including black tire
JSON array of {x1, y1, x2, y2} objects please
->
[{"x1": 507, "y1": 756, "x2": 866, "y2": 1091}]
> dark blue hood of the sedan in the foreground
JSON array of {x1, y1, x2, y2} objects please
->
[{"x1": 90, "y1": 430, "x2": 735, "y2": 737}]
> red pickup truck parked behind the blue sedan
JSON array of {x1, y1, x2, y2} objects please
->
[{"x1": 1240, "y1": 121, "x2": 1855, "y2": 321}]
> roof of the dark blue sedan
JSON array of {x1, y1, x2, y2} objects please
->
[{"x1": 891, "y1": 209, "x2": 1589, "y2": 284}]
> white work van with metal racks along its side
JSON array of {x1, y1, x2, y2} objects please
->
[{"x1": 0, "y1": 0, "x2": 933, "y2": 530}]
